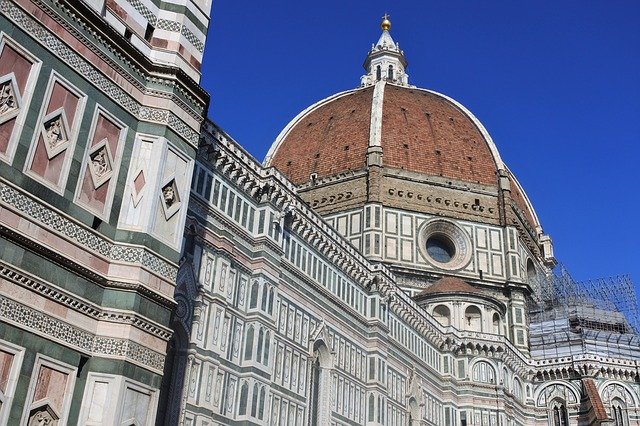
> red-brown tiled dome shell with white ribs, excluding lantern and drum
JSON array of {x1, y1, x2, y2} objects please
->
[{"x1": 266, "y1": 82, "x2": 504, "y2": 186}]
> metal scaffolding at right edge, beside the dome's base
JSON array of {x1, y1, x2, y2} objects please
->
[{"x1": 528, "y1": 266, "x2": 640, "y2": 358}]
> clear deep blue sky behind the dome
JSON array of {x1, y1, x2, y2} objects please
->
[{"x1": 202, "y1": 0, "x2": 640, "y2": 296}]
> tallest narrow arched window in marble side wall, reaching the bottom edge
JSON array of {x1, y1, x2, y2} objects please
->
[{"x1": 308, "y1": 340, "x2": 331, "y2": 426}]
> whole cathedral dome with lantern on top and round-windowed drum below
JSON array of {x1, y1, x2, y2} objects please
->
[{"x1": 264, "y1": 17, "x2": 553, "y2": 271}]
